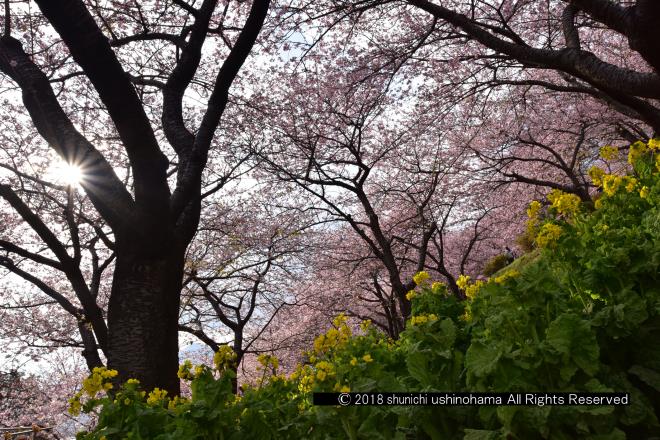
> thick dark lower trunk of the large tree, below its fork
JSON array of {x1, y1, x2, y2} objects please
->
[{"x1": 108, "y1": 245, "x2": 184, "y2": 395}]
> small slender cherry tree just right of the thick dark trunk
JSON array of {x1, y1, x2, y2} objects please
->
[{"x1": 179, "y1": 189, "x2": 312, "y2": 372}]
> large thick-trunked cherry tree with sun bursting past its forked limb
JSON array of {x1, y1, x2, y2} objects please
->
[{"x1": 0, "y1": 0, "x2": 270, "y2": 394}]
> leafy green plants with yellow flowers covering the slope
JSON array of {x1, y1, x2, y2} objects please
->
[{"x1": 78, "y1": 144, "x2": 660, "y2": 440}]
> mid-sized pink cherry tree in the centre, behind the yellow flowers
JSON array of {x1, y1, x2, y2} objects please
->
[{"x1": 248, "y1": 55, "x2": 520, "y2": 337}]
